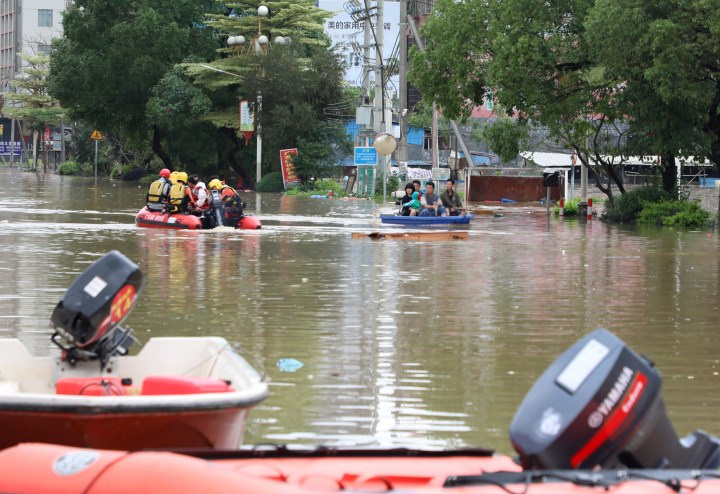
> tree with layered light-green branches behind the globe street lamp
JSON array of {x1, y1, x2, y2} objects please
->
[{"x1": 184, "y1": 0, "x2": 347, "y2": 182}]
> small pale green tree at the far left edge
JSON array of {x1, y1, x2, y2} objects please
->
[{"x1": 3, "y1": 54, "x2": 64, "y2": 169}]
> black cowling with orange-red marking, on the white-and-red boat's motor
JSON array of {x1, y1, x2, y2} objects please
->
[{"x1": 51, "y1": 251, "x2": 144, "y2": 348}]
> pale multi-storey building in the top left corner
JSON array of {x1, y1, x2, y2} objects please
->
[{"x1": 0, "y1": 0, "x2": 67, "y2": 86}]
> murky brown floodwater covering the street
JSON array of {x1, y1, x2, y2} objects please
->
[{"x1": 0, "y1": 168, "x2": 720, "y2": 453}]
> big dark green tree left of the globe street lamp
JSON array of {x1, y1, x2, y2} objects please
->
[{"x1": 48, "y1": 0, "x2": 218, "y2": 167}]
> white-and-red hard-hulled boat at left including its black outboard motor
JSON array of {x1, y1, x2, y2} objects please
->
[{"x1": 0, "y1": 251, "x2": 268, "y2": 450}]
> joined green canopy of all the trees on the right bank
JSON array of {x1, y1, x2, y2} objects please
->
[{"x1": 411, "y1": 0, "x2": 720, "y2": 200}]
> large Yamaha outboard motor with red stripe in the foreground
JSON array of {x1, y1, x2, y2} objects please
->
[{"x1": 510, "y1": 329, "x2": 720, "y2": 469}]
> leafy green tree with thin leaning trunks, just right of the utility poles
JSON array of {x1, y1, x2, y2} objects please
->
[{"x1": 411, "y1": 0, "x2": 676, "y2": 203}]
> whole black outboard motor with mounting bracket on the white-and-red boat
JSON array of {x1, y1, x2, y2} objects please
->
[{"x1": 51, "y1": 251, "x2": 144, "y2": 369}]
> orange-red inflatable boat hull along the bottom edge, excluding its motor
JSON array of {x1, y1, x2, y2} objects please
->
[{"x1": 0, "y1": 443, "x2": 720, "y2": 494}]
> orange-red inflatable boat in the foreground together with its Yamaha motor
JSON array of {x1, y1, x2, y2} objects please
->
[{"x1": 0, "y1": 330, "x2": 720, "y2": 494}]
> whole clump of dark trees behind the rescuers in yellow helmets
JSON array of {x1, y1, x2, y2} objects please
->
[{"x1": 42, "y1": 0, "x2": 352, "y2": 182}]
